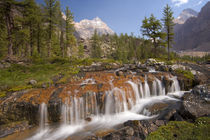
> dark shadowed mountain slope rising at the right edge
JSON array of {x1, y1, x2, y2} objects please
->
[{"x1": 173, "y1": 2, "x2": 210, "y2": 51}]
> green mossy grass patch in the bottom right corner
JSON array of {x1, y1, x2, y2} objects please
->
[{"x1": 147, "y1": 117, "x2": 210, "y2": 140}]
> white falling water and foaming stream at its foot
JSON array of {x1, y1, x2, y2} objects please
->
[{"x1": 29, "y1": 77, "x2": 183, "y2": 140}]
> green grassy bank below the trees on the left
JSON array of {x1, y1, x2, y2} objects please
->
[{"x1": 0, "y1": 58, "x2": 120, "y2": 98}]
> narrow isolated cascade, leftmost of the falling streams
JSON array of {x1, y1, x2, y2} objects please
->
[{"x1": 39, "y1": 103, "x2": 48, "y2": 130}]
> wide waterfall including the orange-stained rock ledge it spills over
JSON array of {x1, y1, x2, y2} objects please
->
[{"x1": 30, "y1": 73, "x2": 185, "y2": 140}]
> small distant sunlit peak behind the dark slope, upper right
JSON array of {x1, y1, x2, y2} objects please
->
[{"x1": 174, "y1": 8, "x2": 198, "y2": 24}]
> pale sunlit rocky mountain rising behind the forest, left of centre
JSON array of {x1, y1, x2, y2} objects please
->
[{"x1": 75, "y1": 17, "x2": 114, "y2": 39}]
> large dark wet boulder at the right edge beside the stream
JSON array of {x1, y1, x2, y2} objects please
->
[{"x1": 180, "y1": 85, "x2": 210, "y2": 120}]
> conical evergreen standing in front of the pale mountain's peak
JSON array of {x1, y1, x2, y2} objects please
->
[{"x1": 91, "y1": 30, "x2": 102, "y2": 58}]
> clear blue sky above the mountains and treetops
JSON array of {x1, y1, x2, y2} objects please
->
[{"x1": 37, "y1": 0, "x2": 209, "y2": 36}]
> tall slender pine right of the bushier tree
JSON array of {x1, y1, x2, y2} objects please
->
[{"x1": 162, "y1": 4, "x2": 175, "y2": 60}]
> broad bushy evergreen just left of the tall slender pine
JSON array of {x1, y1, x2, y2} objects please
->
[{"x1": 141, "y1": 14, "x2": 165, "y2": 57}]
